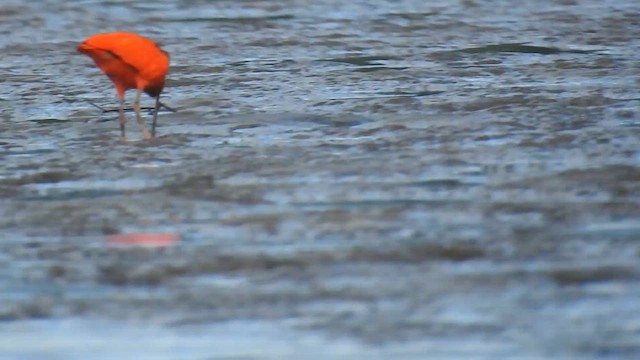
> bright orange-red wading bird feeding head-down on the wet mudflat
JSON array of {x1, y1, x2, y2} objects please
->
[{"x1": 78, "y1": 32, "x2": 169, "y2": 139}]
